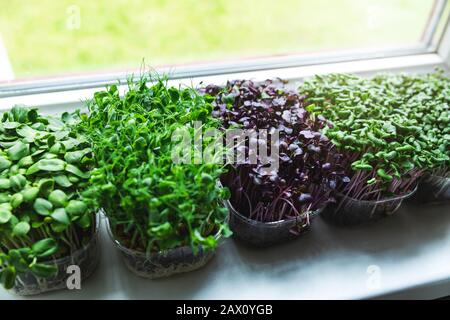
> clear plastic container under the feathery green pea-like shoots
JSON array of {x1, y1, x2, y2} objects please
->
[{"x1": 108, "y1": 218, "x2": 220, "y2": 279}]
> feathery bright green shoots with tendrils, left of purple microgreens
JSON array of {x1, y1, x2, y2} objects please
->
[{"x1": 78, "y1": 76, "x2": 228, "y2": 253}]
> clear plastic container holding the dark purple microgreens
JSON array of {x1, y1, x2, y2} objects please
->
[{"x1": 227, "y1": 201, "x2": 322, "y2": 247}]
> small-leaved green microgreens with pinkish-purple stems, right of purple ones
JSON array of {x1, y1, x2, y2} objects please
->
[{"x1": 299, "y1": 72, "x2": 450, "y2": 200}]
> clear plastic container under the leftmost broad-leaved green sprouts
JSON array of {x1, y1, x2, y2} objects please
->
[{"x1": 11, "y1": 215, "x2": 100, "y2": 296}]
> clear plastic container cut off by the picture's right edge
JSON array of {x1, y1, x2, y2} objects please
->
[{"x1": 414, "y1": 175, "x2": 450, "y2": 204}]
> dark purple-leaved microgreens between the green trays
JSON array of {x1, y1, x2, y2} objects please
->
[{"x1": 204, "y1": 80, "x2": 348, "y2": 222}]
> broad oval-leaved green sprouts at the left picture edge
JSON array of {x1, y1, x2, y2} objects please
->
[{"x1": 0, "y1": 107, "x2": 95, "y2": 289}]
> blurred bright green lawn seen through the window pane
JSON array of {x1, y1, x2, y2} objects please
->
[{"x1": 0, "y1": 0, "x2": 433, "y2": 78}]
